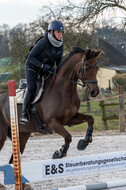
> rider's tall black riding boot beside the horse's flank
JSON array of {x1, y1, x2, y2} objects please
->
[{"x1": 20, "y1": 88, "x2": 34, "y2": 124}]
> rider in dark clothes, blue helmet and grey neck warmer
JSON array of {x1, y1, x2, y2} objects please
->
[{"x1": 20, "y1": 20, "x2": 65, "y2": 129}]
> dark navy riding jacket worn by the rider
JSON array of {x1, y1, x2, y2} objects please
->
[{"x1": 26, "y1": 32, "x2": 63, "y2": 72}]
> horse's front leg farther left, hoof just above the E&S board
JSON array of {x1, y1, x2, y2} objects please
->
[{"x1": 48, "y1": 118, "x2": 72, "y2": 159}]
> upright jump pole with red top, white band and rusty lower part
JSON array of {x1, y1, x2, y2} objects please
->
[{"x1": 8, "y1": 80, "x2": 22, "y2": 190}]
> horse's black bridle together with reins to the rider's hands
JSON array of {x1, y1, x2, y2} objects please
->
[{"x1": 46, "y1": 55, "x2": 98, "y2": 93}]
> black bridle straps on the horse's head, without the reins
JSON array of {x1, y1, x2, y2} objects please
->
[{"x1": 80, "y1": 55, "x2": 98, "y2": 86}]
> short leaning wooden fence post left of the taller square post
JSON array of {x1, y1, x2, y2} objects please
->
[{"x1": 99, "y1": 100, "x2": 108, "y2": 130}]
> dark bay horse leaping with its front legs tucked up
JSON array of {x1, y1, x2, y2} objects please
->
[{"x1": 0, "y1": 47, "x2": 101, "y2": 163}]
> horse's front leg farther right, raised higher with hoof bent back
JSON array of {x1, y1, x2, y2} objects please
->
[{"x1": 68, "y1": 113, "x2": 94, "y2": 150}]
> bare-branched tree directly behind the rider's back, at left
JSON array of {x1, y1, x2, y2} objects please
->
[{"x1": 8, "y1": 21, "x2": 50, "y2": 81}]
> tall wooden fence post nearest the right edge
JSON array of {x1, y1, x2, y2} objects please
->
[{"x1": 118, "y1": 86, "x2": 125, "y2": 132}]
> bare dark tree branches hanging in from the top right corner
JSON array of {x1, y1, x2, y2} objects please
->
[{"x1": 68, "y1": 0, "x2": 126, "y2": 26}]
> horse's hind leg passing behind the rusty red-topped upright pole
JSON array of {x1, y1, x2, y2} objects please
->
[{"x1": 9, "y1": 132, "x2": 31, "y2": 164}]
